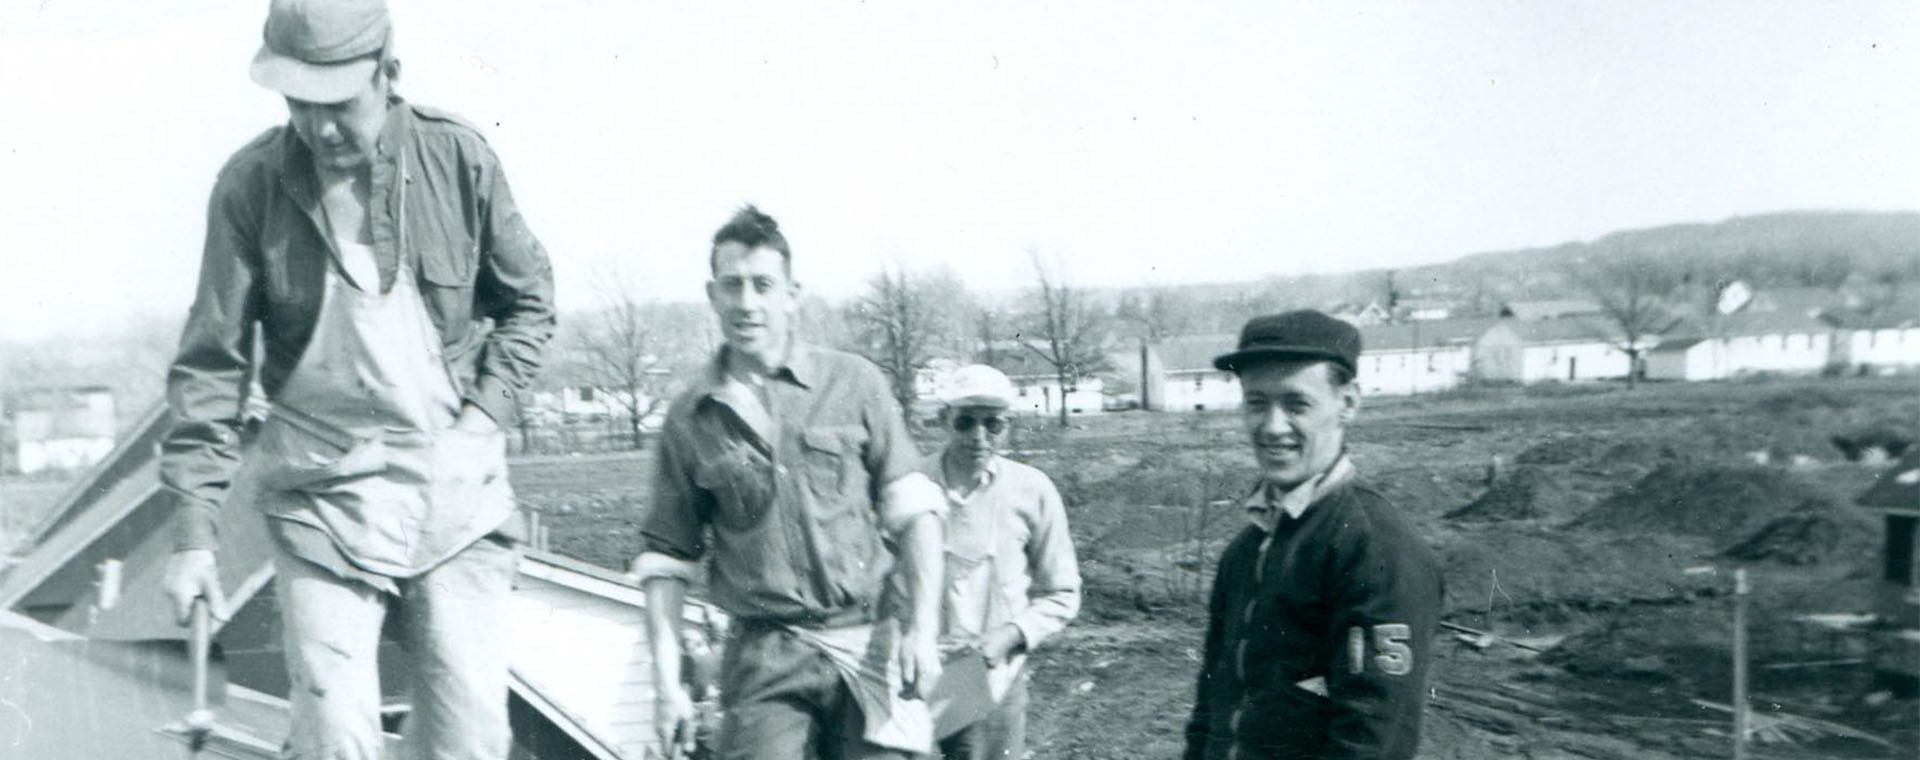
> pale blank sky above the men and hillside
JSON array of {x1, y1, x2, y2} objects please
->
[{"x1": 0, "y1": 0, "x2": 1920, "y2": 340}]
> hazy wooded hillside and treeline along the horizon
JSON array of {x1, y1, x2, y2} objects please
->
[{"x1": 0, "y1": 211, "x2": 1920, "y2": 445}]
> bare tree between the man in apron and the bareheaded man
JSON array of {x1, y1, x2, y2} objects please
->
[{"x1": 574, "y1": 276, "x2": 697, "y2": 449}]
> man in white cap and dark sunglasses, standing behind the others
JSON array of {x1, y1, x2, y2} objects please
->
[{"x1": 924, "y1": 365, "x2": 1081, "y2": 760}]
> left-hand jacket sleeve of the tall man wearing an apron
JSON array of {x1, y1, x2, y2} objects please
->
[{"x1": 159, "y1": 171, "x2": 259, "y2": 549}]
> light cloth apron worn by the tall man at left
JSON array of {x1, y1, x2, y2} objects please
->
[{"x1": 250, "y1": 208, "x2": 515, "y2": 578}]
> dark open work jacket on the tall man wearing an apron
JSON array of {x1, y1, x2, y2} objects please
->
[{"x1": 161, "y1": 98, "x2": 555, "y2": 549}]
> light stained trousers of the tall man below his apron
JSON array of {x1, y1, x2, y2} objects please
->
[{"x1": 275, "y1": 537, "x2": 518, "y2": 760}]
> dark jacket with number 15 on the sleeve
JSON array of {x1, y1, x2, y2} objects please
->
[{"x1": 1187, "y1": 478, "x2": 1442, "y2": 760}]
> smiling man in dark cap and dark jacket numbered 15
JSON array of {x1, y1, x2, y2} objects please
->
[{"x1": 1187, "y1": 311, "x2": 1442, "y2": 760}]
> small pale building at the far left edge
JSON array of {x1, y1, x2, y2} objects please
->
[{"x1": 6, "y1": 386, "x2": 115, "y2": 472}]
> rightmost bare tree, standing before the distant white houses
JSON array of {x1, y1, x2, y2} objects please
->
[{"x1": 1569, "y1": 253, "x2": 1684, "y2": 388}]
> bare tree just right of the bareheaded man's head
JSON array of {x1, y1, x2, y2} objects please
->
[{"x1": 849, "y1": 265, "x2": 958, "y2": 418}]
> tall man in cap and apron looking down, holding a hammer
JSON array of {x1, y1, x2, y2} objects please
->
[{"x1": 161, "y1": 0, "x2": 553, "y2": 758}]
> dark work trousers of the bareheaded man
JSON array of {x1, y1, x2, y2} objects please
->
[{"x1": 718, "y1": 628, "x2": 912, "y2": 760}]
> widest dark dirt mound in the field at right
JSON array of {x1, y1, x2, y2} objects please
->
[{"x1": 1572, "y1": 463, "x2": 1826, "y2": 537}]
